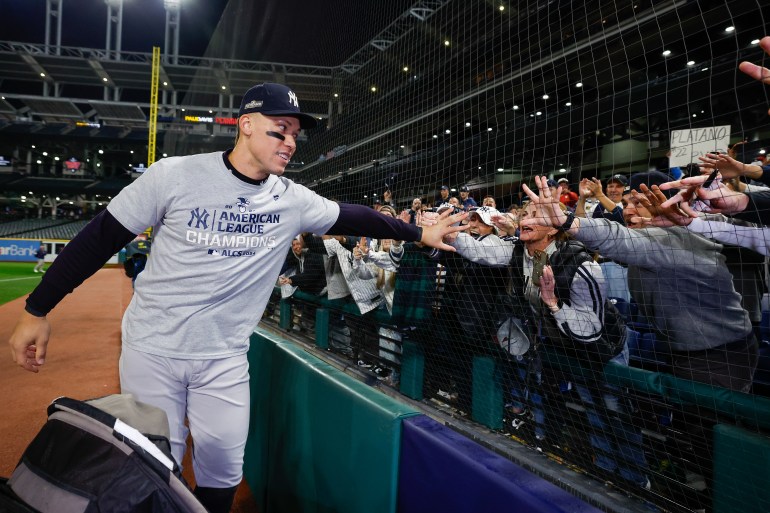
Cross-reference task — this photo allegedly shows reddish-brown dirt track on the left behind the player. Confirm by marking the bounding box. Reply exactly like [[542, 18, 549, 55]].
[[0, 268, 257, 513]]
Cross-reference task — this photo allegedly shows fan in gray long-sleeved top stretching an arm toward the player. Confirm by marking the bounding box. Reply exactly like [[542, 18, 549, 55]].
[[524, 173, 757, 392]]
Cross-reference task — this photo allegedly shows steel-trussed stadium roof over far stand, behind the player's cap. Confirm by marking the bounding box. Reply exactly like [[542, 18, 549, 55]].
[[0, 41, 335, 135]]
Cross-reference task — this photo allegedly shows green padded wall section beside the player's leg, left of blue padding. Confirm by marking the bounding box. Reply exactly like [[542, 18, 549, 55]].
[[244, 328, 419, 513]]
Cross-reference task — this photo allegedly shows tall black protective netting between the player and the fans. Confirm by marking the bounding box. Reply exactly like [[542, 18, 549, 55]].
[[256, 1, 770, 511]]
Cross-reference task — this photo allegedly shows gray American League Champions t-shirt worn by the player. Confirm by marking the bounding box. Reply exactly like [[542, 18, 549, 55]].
[[108, 152, 339, 359]]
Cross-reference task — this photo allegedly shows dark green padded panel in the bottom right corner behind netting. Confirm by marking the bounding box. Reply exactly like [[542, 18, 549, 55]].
[[714, 424, 770, 513]]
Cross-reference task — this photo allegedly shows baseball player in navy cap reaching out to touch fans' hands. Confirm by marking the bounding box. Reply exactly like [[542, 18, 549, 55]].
[[9, 83, 465, 513]]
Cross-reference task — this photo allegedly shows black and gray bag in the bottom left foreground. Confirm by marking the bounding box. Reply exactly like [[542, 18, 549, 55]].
[[9, 394, 206, 513]]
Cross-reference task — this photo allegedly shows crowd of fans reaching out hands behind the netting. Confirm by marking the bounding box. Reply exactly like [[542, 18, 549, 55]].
[[268, 142, 770, 489]]
